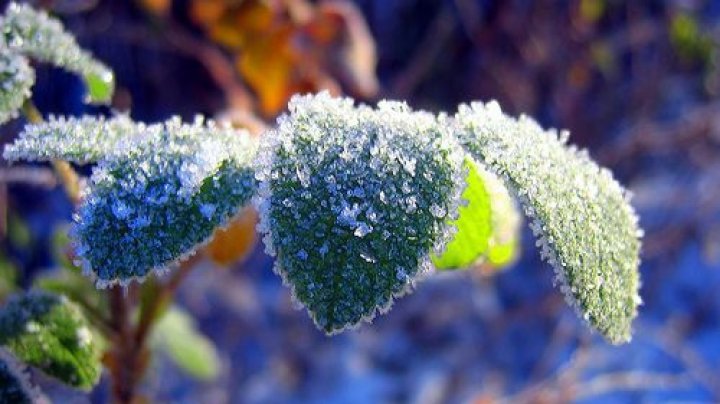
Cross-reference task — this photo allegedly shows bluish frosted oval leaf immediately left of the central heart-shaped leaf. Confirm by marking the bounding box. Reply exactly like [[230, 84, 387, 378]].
[[73, 119, 255, 287]]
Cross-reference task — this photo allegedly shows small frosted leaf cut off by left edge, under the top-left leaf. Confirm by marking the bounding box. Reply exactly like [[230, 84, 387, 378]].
[[0, 46, 35, 124]]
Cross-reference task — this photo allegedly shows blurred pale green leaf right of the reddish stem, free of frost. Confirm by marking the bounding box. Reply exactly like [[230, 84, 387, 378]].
[[151, 307, 220, 380]]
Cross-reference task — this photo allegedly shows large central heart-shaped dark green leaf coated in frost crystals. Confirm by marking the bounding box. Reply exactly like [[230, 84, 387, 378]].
[[257, 93, 463, 333]]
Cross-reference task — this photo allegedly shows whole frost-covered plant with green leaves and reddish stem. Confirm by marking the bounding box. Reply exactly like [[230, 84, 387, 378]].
[[0, 3, 641, 402]]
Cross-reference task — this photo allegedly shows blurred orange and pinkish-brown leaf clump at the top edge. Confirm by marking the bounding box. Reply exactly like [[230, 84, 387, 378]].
[[191, 0, 378, 116]]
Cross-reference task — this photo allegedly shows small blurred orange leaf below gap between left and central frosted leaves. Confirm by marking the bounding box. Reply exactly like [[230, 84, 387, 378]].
[[205, 206, 258, 267]]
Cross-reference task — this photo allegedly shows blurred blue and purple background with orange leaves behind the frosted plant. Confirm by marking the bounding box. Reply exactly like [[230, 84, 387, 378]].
[[0, 0, 720, 403]]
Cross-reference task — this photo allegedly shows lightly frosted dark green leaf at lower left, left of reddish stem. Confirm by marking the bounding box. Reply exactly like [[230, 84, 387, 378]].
[[0, 292, 102, 390]]
